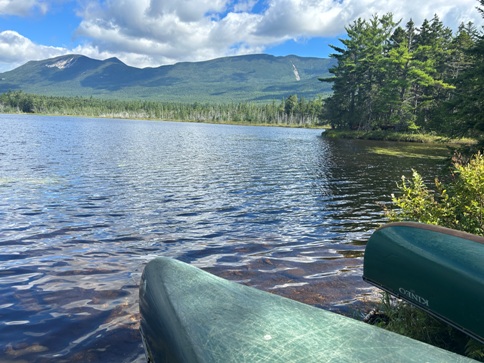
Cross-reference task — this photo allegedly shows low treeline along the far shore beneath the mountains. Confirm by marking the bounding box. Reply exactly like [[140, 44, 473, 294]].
[[0, 91, 324, 127]]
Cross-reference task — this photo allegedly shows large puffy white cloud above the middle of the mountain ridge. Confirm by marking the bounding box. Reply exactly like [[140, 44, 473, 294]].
[[74, 0, 263, 65]]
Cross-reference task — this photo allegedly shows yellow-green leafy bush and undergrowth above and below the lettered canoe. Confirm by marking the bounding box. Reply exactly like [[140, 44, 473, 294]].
[[379, 153, 484, 361]]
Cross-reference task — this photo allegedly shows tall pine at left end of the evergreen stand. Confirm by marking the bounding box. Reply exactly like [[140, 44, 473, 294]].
[[321, 14, 397, 130]]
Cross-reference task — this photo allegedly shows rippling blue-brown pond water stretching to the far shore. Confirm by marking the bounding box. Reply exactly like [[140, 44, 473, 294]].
[[0, 115, 446, 362]]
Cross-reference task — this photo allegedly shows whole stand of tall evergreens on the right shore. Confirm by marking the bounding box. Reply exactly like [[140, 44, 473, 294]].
[[321, 8, 484, 144]]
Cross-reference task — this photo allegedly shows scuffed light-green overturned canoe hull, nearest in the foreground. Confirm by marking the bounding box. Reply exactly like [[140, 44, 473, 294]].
[[140, 257, 472, 363]]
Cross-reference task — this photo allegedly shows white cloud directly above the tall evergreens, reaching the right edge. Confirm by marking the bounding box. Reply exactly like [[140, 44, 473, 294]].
[[257, 0, 481, 38]]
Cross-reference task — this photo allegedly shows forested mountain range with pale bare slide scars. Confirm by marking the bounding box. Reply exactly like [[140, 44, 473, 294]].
[[0, 54, 334, 102]]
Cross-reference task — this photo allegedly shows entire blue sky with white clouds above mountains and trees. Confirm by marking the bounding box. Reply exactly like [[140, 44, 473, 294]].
[[0, 0, 482, 72]]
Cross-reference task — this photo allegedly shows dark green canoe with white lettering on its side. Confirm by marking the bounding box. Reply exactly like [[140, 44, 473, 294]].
[[363, 222, 484, 343]]
